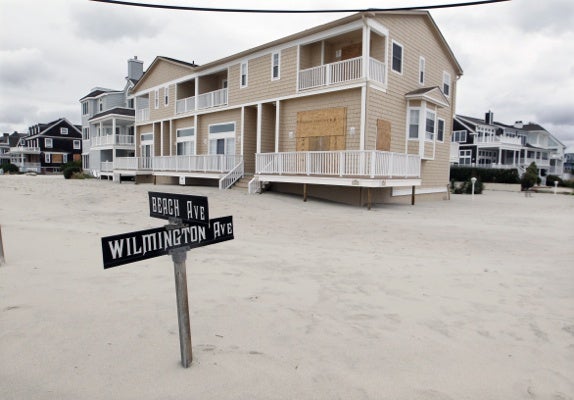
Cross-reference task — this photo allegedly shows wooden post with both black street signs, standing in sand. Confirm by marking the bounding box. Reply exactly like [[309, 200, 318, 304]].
[[102, 192, 234, 368]]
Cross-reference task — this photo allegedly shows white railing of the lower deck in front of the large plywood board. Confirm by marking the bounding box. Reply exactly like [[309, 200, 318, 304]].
[[255, 150, 421, 178]]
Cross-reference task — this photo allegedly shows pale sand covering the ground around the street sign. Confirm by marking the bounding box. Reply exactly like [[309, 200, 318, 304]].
[[0, 176, 574, 400]]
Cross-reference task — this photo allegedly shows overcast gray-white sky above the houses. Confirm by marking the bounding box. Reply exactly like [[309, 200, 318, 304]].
[[0, 0, 574, 151]]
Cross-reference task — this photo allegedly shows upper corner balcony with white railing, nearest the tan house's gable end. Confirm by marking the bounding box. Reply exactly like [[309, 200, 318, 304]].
[[297, 29, 387, 91]]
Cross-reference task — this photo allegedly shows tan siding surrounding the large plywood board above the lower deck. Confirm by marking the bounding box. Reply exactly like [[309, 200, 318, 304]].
[[279, 89, 361, 152]]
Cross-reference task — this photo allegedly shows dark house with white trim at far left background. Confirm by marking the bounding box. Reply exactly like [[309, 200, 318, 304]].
[[9, 118, 82, 173]]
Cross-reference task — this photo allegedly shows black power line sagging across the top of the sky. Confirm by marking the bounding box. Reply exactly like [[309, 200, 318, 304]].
[[90, 0, 511, 14]]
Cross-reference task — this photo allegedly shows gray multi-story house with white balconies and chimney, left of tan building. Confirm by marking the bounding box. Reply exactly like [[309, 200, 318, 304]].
[[80, 57, 143, 177]]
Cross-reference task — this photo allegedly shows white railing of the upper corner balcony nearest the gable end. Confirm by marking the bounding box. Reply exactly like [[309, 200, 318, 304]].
[[299, 57, 386, 90]]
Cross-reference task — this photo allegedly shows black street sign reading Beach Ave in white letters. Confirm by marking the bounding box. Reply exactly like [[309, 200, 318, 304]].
[[149, 192, 209, 225]]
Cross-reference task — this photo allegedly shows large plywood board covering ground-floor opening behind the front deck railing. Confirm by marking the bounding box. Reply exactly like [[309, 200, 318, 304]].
[[297, 107, 347, 151]]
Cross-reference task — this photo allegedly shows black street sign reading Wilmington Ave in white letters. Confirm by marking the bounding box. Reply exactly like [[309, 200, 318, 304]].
[[102, 216, 233, 269]]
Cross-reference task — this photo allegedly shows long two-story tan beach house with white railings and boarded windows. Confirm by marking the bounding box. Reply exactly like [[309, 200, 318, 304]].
[[113, 11, 462, 204]]
